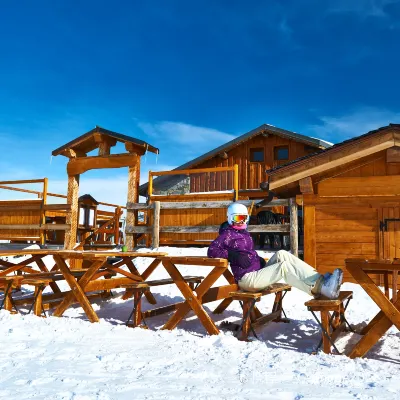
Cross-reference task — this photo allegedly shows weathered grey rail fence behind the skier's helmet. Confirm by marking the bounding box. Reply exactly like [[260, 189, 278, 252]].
[[125, 199, 298, 256]]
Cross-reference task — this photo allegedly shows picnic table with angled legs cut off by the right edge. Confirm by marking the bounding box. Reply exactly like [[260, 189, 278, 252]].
[[345, 259, 400, 358]]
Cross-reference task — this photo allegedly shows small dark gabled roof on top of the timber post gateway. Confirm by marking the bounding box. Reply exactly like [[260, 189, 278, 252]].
[[51, 125, 160, 156]]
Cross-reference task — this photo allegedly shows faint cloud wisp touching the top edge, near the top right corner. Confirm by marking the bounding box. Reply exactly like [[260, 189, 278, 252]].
[[329, 0, 399, 18]]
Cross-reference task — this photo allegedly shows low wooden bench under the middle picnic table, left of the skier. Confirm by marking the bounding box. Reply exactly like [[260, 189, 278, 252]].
[[121, 276, 204, 328]]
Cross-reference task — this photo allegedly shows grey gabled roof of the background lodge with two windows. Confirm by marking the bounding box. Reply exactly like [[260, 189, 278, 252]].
[[139, 124, 332, 196]]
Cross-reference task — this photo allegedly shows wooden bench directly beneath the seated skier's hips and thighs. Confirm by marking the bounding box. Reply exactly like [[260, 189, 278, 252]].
[[223, 283, 291, 340]]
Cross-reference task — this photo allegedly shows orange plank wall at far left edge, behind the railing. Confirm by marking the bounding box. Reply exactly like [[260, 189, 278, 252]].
[[0, 199, 43, 240]]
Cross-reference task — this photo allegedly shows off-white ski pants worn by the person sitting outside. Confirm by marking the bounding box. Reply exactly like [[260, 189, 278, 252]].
[[239, 250, 320, 295]]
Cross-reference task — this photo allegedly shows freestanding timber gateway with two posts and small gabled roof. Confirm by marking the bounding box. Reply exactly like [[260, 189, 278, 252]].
[[52, 126, 159, 250]]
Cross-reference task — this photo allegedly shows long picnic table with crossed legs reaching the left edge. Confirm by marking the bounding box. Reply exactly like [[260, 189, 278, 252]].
[[0, 249, 166, 322]]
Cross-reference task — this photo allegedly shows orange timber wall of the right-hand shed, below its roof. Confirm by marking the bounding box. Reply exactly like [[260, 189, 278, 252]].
[[302, 151, 400, 280]]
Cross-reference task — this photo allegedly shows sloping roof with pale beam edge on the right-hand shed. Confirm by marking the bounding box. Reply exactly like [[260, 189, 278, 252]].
[[266, 124, 400, 192]]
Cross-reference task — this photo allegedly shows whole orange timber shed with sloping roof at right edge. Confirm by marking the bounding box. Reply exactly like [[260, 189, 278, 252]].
[[268, 124, 400, 286]]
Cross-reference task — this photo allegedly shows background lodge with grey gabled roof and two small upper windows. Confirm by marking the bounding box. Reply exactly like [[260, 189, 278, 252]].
[[139, 124, 332, 198]]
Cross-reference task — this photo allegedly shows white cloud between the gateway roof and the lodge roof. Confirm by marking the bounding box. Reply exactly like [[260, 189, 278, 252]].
[[138, 121, 235, 147]]
